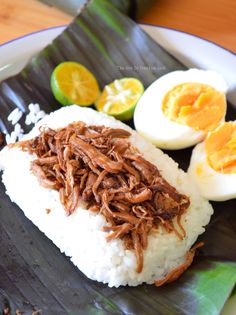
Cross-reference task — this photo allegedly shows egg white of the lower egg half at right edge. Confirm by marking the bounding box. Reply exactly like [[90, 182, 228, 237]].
[[188, 142, 236, 201]]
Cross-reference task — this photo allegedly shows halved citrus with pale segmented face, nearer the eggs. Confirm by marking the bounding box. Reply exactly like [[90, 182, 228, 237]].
[[95, 78, 144, 120]]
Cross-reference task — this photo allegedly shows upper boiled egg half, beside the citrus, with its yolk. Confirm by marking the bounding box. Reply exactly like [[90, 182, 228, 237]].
[[134, 69, 227, 150]]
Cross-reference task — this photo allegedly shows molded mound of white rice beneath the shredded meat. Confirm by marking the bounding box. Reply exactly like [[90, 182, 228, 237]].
[[0, 105, 213, 287]]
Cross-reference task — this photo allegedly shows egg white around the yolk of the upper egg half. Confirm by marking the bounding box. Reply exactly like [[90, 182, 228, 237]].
[[134, 69, 227, 150]]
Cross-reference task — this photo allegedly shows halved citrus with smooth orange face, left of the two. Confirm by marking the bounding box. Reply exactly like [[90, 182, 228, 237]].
[[51, 61, 100, 106]]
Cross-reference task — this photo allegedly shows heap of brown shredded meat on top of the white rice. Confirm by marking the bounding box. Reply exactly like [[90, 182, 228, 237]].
[[20, 122, 189, 272]]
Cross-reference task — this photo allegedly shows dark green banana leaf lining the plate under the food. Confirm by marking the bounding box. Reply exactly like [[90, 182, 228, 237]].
[[0, 0, 236, 315]]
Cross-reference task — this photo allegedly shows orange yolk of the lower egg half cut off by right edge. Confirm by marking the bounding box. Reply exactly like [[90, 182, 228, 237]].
[[205, 122, 236, 174]]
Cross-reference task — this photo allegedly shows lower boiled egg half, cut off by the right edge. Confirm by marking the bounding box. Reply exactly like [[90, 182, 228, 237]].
[[188, 121, 236, 201]]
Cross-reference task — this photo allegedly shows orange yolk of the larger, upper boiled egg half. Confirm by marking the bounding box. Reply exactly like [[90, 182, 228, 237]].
[[162, 82, 226, 131]]
